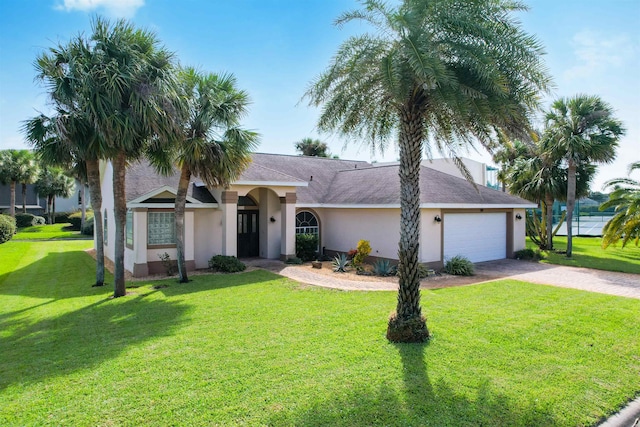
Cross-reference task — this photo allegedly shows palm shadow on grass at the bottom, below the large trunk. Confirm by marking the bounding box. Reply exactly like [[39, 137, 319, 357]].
[[269, 344, 557, 426]]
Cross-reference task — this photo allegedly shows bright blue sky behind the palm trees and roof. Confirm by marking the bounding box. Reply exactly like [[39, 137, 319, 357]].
[[0, 0, 640, 190]]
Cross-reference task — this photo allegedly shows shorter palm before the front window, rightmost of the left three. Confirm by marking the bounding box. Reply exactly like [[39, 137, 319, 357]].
[[164, 68, 258, 283]]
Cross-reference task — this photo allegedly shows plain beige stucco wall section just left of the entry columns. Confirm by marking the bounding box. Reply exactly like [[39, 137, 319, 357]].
[[194, 209, 222, 268]]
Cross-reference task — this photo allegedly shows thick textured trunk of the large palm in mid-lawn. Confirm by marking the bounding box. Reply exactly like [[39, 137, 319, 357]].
[[387, 107, 429, 342]]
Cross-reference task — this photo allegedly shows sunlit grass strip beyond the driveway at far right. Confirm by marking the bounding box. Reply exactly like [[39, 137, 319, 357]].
[[527, 236, 640, 274]]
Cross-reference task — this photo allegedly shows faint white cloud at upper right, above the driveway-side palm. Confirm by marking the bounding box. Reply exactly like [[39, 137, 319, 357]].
[[564, 31, 636, 80]]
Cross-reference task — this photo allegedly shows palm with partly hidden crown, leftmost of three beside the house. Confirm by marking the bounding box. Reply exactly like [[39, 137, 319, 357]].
[[22, 112, 106, 286]]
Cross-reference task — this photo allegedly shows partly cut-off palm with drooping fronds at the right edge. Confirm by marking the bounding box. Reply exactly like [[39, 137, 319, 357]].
[[600, 161, 640, 249]]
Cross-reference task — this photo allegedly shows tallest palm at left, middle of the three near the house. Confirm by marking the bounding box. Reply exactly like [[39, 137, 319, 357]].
[[38, 18, 180, 297]]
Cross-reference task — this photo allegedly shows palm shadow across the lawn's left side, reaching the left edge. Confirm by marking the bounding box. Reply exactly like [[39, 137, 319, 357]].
[[0, 291, 189, 390]]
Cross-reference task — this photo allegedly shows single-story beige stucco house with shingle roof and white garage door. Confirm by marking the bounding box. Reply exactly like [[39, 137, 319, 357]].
[[101, 153, 536, 276]]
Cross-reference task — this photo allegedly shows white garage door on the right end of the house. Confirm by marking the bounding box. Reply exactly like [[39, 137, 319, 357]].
[[443, 212, 507, 262]]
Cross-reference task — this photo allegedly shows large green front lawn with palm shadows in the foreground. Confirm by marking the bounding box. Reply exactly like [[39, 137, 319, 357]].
[[0, 241, 640, 426]]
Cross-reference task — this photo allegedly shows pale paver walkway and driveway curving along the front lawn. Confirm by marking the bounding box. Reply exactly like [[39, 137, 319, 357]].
[[250, 259, 640, 299]]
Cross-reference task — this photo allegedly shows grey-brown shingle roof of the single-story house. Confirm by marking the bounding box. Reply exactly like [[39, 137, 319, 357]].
[[126, 153, 531, 206]]
